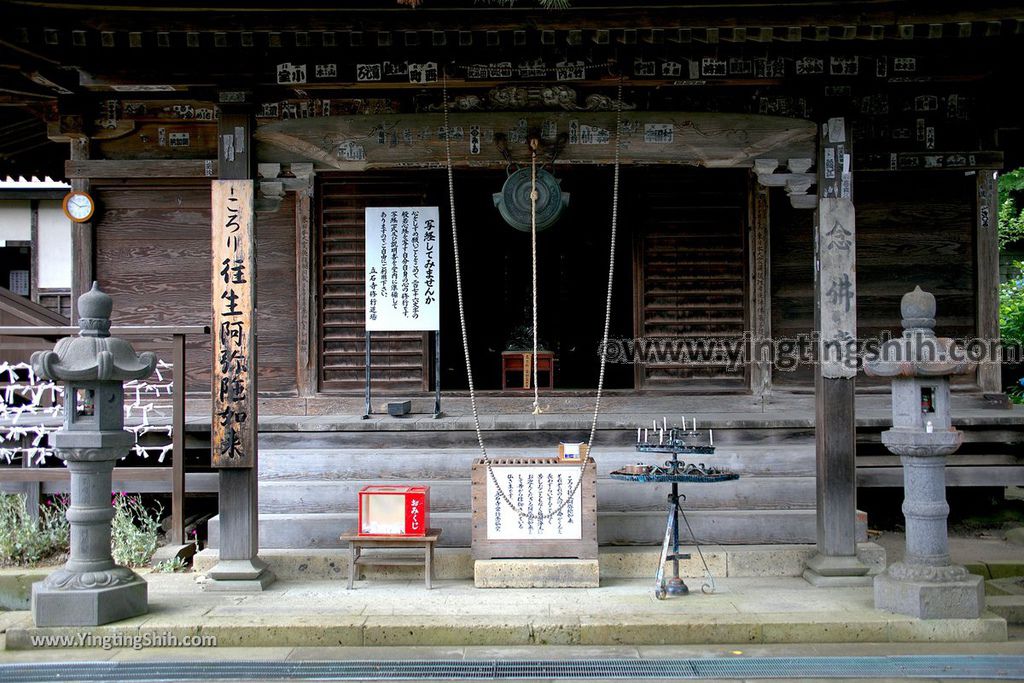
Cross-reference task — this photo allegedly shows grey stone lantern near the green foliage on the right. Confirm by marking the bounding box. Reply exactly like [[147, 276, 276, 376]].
[[864, 287, 985, 618]]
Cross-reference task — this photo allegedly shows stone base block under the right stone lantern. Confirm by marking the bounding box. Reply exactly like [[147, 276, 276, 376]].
[[874, 572, 985, 618]]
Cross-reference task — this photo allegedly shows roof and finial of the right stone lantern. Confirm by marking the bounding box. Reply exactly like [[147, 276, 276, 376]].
[[864, 287, 976, 377]]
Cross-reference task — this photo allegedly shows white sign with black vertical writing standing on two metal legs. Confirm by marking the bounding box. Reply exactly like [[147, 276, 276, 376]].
[[366, 207, 440, 331]]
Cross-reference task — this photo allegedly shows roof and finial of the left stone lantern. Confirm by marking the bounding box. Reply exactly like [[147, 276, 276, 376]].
[[32, 283, 157, 382]]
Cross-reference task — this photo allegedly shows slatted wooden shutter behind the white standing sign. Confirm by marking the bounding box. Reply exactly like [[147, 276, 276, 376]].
[[319, 173, 429, 397]]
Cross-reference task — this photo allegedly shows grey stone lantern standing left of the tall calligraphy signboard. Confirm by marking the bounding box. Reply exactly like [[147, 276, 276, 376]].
[[32, 283, 157, 626]]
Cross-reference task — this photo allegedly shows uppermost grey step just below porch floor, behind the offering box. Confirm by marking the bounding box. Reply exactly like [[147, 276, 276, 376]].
[[259, 444, 815, 483]]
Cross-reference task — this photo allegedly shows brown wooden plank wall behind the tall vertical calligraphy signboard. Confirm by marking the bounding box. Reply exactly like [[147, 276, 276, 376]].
[[93, 181, 296, 395]]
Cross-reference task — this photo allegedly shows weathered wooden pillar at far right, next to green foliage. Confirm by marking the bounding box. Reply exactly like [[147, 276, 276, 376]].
[[975, 169, 1002, 394]]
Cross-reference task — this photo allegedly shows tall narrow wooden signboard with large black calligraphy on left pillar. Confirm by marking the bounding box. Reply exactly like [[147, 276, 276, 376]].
[[212, 180, 256, 467]]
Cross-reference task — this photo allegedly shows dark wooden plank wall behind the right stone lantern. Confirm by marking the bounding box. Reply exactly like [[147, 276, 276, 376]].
[[771, 171, 976, 387]]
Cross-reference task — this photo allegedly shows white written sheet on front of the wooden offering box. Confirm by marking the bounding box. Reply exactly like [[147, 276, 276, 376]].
[[487, 465, 583, 541]]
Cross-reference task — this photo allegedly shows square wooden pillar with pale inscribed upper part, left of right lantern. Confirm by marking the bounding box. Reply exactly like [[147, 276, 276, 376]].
[[804, 119, 870, 586]]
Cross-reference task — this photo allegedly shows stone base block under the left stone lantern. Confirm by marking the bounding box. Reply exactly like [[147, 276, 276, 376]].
[[32, 577, 150, 626]]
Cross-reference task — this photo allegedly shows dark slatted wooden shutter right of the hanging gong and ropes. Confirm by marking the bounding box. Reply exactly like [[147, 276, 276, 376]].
[[635, 169, 746, 389]]
